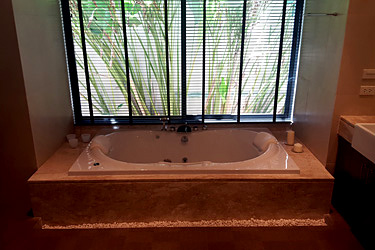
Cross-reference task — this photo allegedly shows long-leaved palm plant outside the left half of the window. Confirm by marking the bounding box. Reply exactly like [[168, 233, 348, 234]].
[[70, 0, 180, 115]]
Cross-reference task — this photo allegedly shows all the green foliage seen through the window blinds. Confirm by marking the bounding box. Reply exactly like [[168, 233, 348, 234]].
[[70, 0, 294, 116]]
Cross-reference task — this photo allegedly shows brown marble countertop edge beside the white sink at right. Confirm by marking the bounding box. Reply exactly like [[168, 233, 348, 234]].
[[337, 115, 375, 143]]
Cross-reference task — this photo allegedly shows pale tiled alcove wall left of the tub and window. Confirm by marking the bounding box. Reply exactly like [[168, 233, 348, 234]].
[[13, 0, 73, 166]]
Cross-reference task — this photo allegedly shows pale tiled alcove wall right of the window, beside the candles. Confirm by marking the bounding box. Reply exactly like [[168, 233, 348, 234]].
[[294, 0, 352, 168]]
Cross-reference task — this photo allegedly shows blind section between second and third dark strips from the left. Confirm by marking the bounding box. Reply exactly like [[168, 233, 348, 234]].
[[125, 1, 168, 116]]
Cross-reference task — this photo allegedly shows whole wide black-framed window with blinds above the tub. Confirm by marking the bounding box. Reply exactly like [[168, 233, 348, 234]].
[[61, 0, 303, 124]]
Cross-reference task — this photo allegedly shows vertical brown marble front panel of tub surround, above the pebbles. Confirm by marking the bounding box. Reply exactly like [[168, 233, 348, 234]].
[[30, 181, 332, 225]]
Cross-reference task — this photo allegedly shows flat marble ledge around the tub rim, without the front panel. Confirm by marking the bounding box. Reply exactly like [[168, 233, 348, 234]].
[[29, 129, 333, 183]]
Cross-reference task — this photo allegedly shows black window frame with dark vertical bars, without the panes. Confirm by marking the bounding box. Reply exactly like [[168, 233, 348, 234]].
[[60, 0, 304, 125]]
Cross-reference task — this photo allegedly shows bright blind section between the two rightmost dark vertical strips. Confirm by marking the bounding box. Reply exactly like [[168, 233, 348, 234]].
[[241, 0, 288, 115]]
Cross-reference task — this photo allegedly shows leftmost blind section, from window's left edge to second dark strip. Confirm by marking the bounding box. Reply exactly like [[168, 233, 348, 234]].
[[71, 0, 129, 116]]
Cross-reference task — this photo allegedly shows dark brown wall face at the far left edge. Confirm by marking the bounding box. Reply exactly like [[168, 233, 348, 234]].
[[0, 0, 37, 221]]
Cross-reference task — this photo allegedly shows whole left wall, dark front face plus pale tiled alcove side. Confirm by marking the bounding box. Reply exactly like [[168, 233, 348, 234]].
[[0, 0, 73, 222]]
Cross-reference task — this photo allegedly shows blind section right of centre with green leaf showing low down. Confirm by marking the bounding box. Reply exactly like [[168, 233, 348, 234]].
[[205, 0, 244, 115]]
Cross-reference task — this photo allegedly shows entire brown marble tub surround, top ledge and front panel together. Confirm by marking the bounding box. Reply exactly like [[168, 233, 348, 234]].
[[29, 127, 333, 225]]
